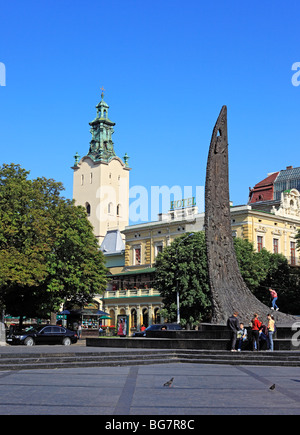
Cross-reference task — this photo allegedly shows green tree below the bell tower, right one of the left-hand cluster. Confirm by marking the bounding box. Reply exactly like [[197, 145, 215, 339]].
[[43, 201, 107, 316]]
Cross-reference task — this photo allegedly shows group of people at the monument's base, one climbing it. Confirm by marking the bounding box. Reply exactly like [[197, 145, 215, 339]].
[[227, 289, 279, 352]]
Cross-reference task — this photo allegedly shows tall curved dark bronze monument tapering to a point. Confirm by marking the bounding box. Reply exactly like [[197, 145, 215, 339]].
[[205, 106, 296, 325]]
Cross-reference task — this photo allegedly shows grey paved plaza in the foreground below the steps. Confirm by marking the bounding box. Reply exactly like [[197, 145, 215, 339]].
[[0, 346, 300, 418]]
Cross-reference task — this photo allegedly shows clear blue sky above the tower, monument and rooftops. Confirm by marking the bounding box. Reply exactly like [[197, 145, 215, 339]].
[[0, 0, 300, 223]]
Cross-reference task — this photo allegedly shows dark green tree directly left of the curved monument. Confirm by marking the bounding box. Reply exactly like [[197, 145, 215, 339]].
[[154, 232, 211, 326]]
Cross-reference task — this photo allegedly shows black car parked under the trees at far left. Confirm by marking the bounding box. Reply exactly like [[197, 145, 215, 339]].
[[6, 325, 78, 346]]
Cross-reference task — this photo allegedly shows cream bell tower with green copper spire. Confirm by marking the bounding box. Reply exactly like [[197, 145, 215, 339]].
[[72, 88, 130, 245]]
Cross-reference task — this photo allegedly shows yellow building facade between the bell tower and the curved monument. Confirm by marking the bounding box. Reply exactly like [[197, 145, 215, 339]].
[[103, 202, 204, 334]]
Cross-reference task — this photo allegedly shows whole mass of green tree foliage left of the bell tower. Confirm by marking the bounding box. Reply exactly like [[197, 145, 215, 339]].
[[0, 164, 106, 316]]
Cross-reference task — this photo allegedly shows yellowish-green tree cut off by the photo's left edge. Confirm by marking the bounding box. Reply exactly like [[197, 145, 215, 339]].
[[0, 164, 49, 288]]
